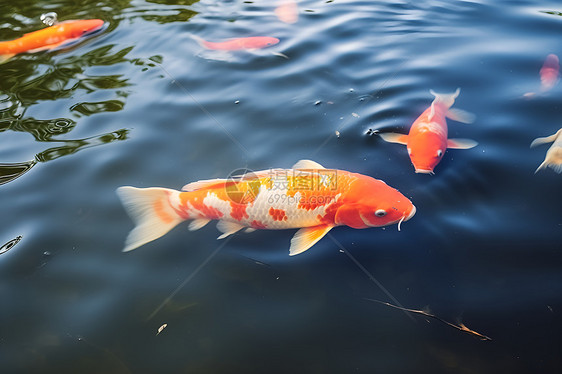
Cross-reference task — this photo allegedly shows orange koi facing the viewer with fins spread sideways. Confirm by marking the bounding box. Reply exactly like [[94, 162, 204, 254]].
[[380, 88, 478, 174]]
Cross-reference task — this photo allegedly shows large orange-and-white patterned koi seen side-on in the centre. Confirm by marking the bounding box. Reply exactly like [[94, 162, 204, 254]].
[[117, 160, 416, 256]]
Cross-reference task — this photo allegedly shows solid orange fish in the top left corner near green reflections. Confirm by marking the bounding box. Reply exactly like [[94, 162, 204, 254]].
[[0, 19, 104, 60]]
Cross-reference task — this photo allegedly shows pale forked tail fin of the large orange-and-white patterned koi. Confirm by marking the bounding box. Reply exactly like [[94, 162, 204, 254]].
[[117, 186, 183, 252]]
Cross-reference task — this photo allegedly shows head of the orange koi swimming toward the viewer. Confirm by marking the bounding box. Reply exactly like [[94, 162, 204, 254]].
[[406, 131, 447, 174]]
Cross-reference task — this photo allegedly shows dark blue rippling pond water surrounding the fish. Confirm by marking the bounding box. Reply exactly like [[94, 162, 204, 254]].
[[0, 0, 562, 373]]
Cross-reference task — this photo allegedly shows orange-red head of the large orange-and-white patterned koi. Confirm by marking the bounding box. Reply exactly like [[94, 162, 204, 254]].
[[334, 174, 416, 230]]
